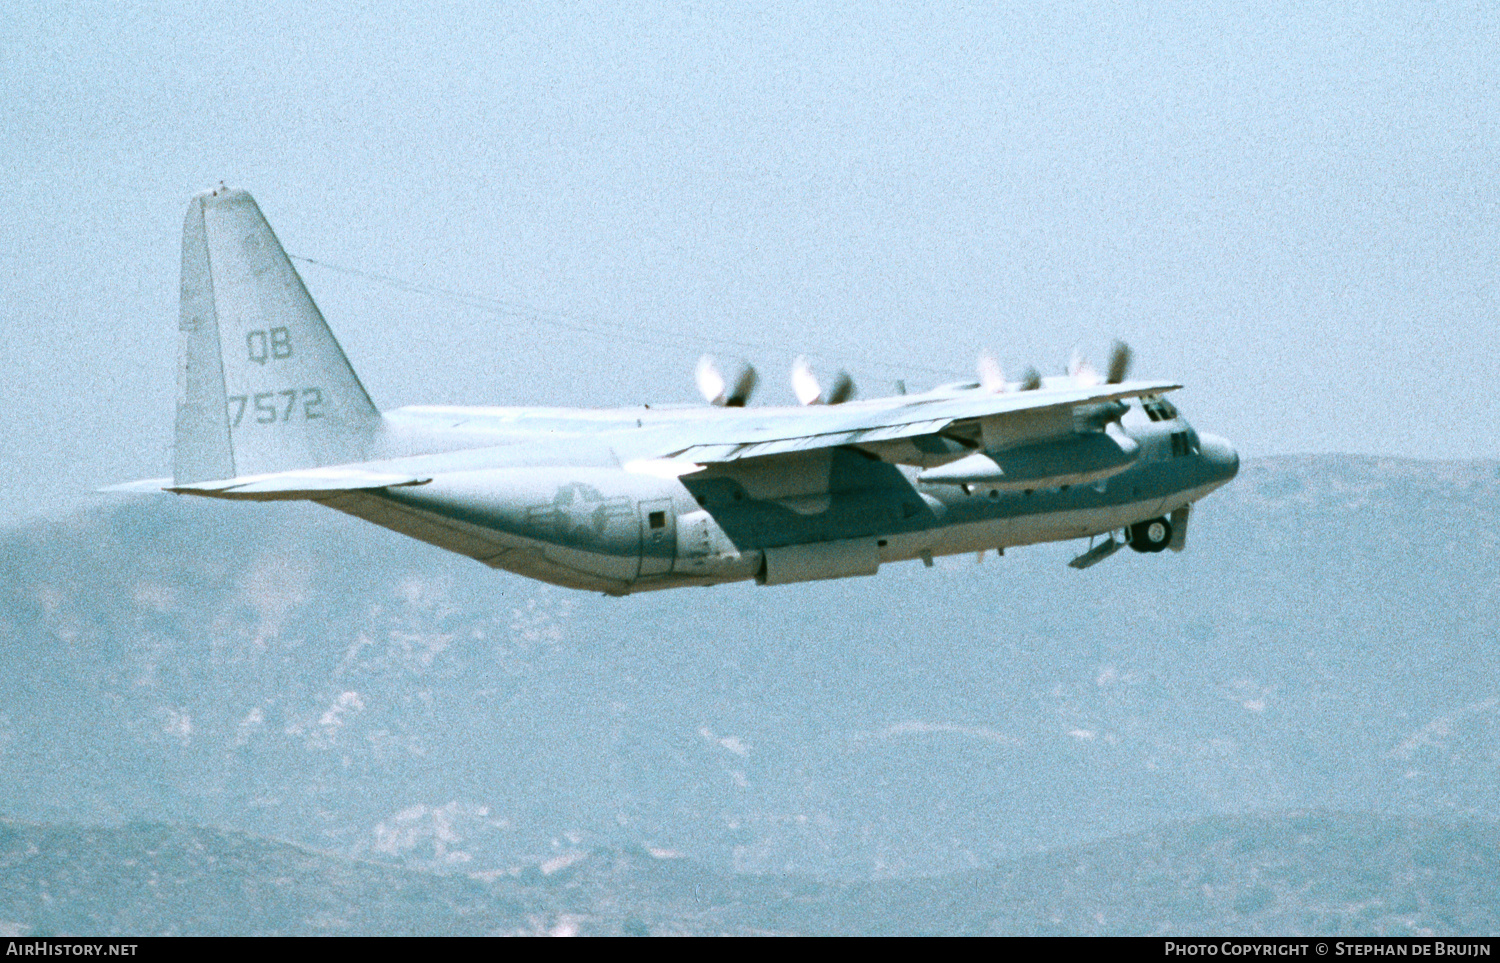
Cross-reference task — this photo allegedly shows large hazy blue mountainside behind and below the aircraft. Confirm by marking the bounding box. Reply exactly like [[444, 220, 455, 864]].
[[0, 456, 1500, 876]]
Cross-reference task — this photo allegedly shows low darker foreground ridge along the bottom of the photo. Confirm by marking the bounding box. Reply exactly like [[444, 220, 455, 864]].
[[0, 813, 1500, 936]]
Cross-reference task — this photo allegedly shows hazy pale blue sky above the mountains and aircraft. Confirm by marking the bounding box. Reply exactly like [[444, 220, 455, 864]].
[[0, 0, 1500, 521]]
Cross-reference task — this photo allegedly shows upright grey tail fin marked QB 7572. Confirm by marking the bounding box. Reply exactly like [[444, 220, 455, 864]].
[[173, 188, 380, 485]]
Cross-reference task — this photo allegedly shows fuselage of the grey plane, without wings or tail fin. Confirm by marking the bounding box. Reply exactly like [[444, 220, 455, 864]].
[[310, 396, 1239, 594]]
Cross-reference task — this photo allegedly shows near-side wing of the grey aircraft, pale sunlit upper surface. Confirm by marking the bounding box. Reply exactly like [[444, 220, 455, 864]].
[[668, 381, 1182, 465]]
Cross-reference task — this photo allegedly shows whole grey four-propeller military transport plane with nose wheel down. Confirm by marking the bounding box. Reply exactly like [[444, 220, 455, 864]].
[[113, 186, 1239, 596]]
